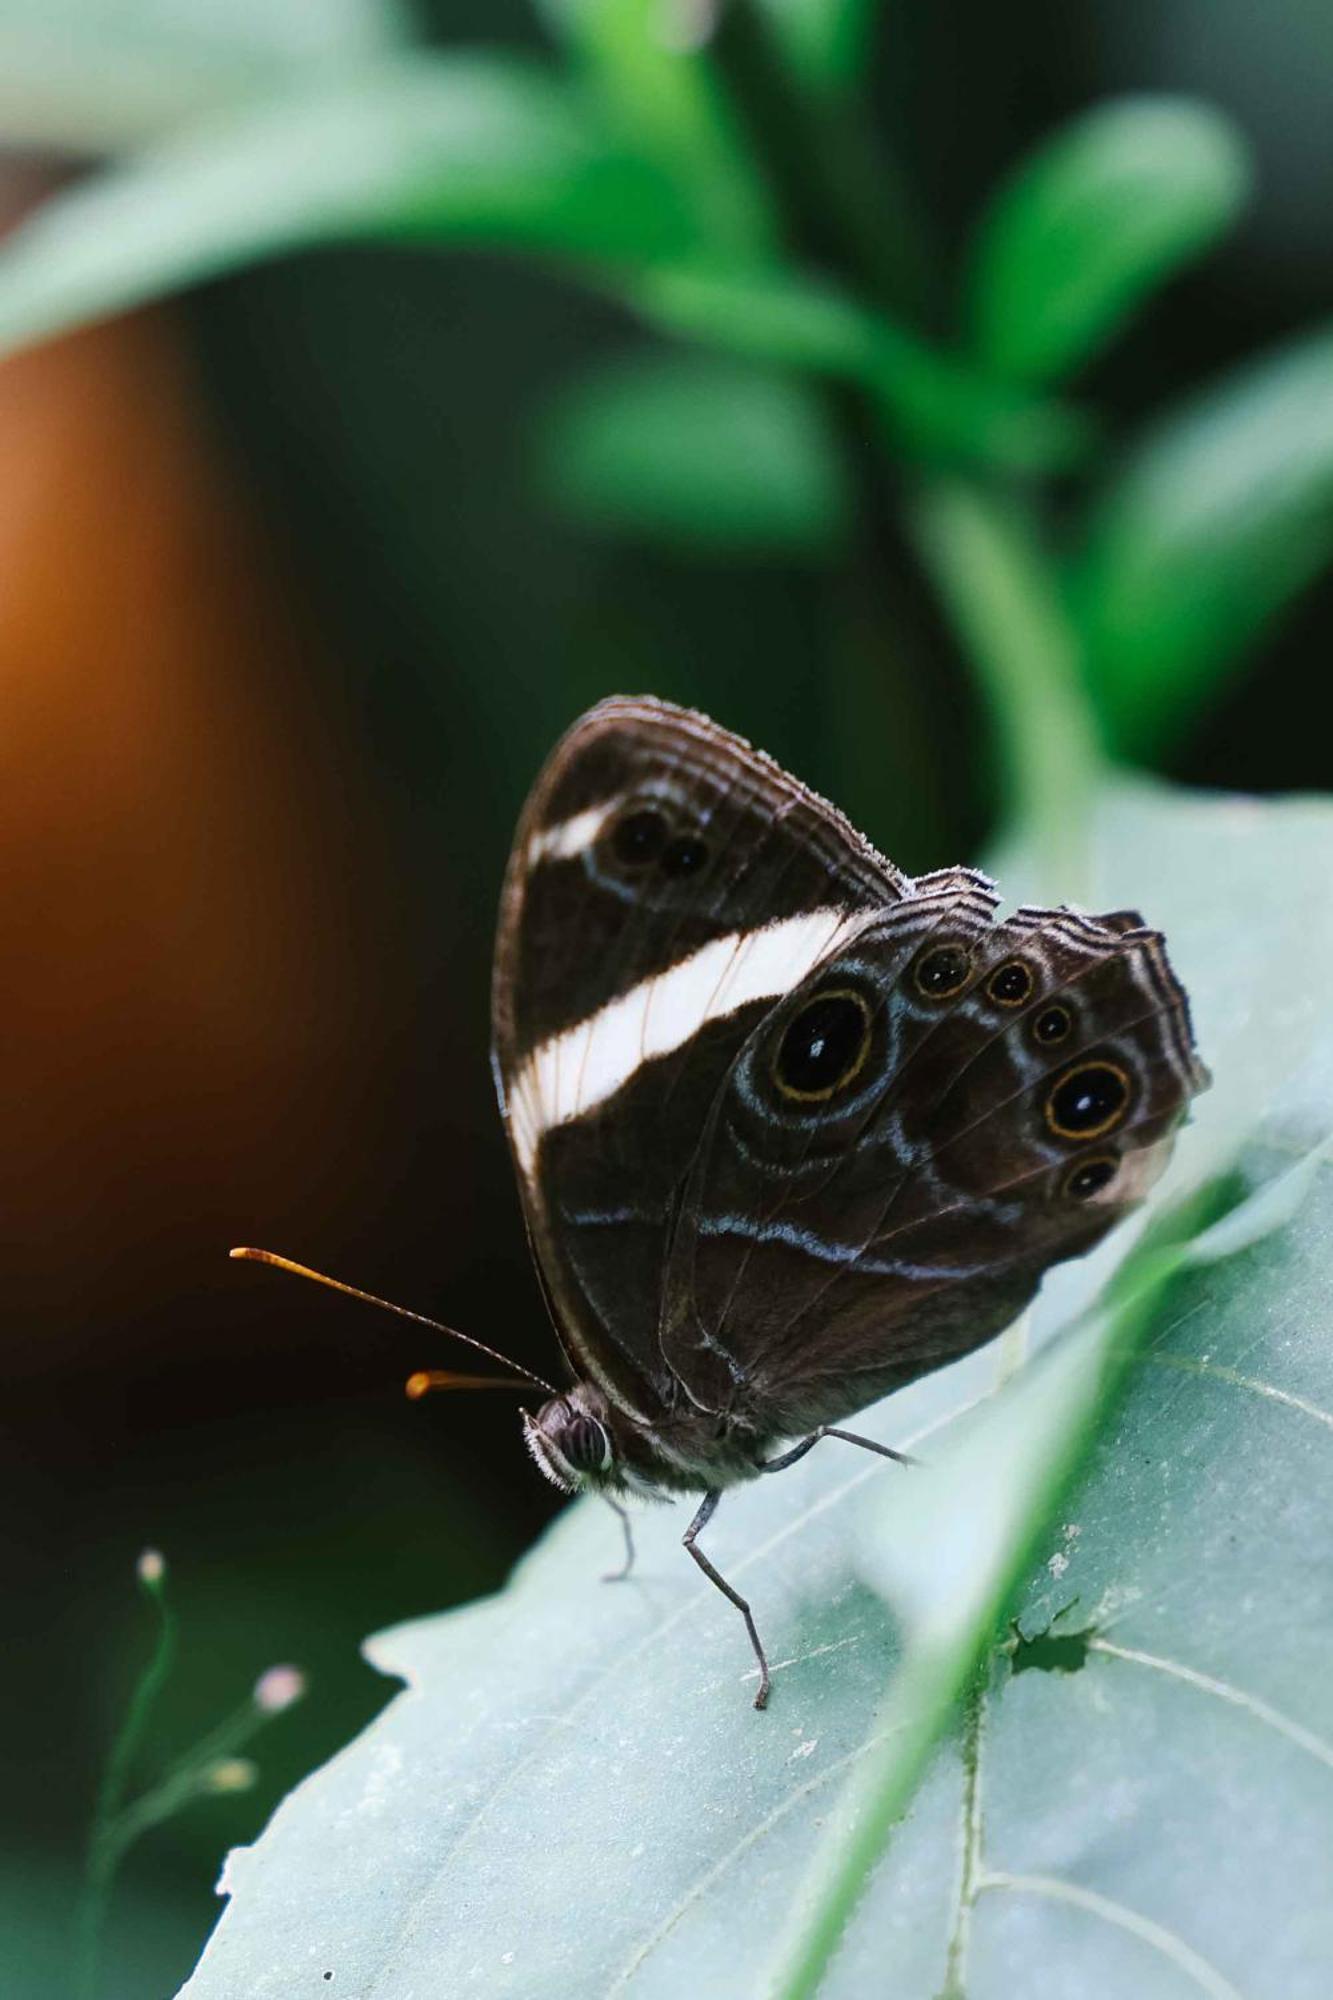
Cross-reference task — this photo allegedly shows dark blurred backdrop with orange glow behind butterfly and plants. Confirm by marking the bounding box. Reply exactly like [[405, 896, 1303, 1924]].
[[0, 0, 1333, 1994]]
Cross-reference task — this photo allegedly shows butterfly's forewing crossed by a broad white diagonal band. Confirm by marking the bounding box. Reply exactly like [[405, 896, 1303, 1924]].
[[492, 700, 907, 1414]]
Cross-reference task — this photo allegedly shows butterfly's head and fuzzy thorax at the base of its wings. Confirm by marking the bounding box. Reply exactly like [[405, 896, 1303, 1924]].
[[522, 1382, 765, 1498]]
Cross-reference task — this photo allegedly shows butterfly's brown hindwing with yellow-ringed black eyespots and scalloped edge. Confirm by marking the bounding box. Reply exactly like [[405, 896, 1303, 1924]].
[[662, 900, 1205, 1434]]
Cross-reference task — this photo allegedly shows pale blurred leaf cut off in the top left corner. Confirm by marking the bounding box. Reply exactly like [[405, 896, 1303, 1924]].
[[0, 0, 408, 154]]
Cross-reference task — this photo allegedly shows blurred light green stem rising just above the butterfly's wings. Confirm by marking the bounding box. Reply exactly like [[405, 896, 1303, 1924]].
[[909, 478, 1101, 896]]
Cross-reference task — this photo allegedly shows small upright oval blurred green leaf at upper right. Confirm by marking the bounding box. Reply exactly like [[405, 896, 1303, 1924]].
[[967, 98, 1251, 382]]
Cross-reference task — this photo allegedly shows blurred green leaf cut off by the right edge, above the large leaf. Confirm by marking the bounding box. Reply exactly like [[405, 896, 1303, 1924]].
[[1073, 328, 1333, 756]]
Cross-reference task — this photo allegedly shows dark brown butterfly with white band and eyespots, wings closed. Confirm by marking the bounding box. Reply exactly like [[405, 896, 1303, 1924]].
[[234, 696, 1209, 1708]]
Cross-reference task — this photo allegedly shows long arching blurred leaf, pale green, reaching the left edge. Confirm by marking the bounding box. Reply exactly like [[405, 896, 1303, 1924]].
[[0, 56, 695, 360]]
